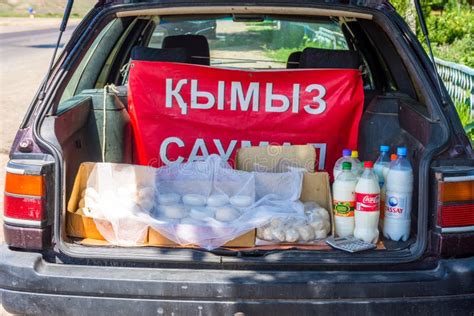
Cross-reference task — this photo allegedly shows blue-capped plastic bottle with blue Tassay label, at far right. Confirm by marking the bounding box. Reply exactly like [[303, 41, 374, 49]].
[[383, 147, 413, 241]]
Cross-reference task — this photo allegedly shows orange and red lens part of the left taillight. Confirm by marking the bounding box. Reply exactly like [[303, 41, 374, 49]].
[[4, 172, 45, 222]]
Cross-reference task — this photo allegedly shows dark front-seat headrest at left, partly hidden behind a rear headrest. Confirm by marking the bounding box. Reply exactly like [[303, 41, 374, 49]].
[[161, 34, 210, 66]]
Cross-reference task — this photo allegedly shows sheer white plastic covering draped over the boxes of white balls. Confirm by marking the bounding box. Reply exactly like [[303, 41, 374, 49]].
[[85, 155, 304, 249]]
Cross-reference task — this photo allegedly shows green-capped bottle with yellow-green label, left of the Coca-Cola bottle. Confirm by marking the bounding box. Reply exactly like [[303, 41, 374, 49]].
[[332, 161, 357, 237]]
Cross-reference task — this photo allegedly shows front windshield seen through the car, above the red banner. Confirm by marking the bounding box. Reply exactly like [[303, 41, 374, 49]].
[[149, 18, 348, 69]]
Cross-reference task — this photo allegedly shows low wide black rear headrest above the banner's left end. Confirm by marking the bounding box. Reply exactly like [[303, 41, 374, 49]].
[[131, 46, 188, 63]]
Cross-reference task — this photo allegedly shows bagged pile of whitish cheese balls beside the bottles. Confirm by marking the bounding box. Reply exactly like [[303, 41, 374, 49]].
[[257, 203, 331, 243]]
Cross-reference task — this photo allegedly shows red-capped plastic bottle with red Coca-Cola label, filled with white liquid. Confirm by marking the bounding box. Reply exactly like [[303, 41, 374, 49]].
[[354, 161, 380, 243]]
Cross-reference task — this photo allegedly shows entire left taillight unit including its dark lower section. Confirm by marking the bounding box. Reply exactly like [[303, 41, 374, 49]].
[[3, 159, 53, 250]]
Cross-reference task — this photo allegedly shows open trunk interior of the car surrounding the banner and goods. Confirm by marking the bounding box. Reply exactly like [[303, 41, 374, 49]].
[[41, 5, 448, 265]]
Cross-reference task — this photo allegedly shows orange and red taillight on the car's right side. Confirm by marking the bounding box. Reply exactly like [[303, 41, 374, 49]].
[[438, 176, 474, 232]]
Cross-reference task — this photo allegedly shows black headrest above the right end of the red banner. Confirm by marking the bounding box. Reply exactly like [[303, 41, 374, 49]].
[[300, 47, 361, 69]]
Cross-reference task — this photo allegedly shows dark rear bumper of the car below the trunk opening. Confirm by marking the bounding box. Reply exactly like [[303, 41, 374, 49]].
[[0, 246, 474, 315]]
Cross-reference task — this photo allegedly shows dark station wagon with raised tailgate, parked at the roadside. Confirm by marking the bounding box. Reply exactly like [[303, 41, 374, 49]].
[[0, 0, 474, 315]]
